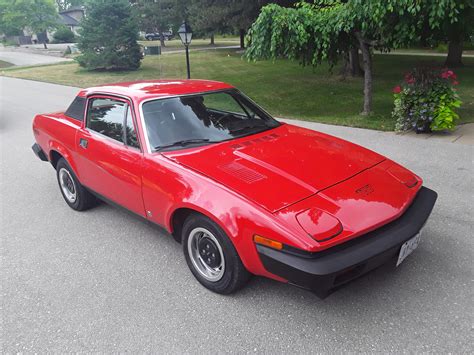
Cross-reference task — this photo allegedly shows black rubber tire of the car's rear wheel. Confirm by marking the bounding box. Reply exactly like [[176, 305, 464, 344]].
[[56, 158, 98, 211]]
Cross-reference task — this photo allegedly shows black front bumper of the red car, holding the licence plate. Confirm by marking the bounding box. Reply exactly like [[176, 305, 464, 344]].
[[257, 187, 438, 298]]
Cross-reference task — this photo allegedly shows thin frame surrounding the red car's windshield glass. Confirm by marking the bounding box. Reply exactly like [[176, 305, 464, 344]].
[[138, 88, 281, 154]]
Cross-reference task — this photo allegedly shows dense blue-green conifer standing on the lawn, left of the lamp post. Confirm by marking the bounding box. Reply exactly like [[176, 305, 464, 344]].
[[77, 0, 142, 70]]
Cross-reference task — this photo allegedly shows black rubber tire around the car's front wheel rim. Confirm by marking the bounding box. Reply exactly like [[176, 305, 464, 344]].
[[181, 214, 251, 294]]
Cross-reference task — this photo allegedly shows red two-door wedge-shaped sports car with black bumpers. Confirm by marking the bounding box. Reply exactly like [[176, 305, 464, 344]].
[[33, 80, 437, 297]]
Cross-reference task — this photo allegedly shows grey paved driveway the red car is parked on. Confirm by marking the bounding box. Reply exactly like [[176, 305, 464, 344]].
[[0, 77, 474, 354]]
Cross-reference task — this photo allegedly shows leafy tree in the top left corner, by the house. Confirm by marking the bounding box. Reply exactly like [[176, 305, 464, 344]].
[[0, 0, 58, 49]]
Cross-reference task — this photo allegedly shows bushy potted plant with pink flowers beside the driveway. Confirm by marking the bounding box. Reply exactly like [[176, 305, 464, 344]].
[[392, 68, 461, 133]]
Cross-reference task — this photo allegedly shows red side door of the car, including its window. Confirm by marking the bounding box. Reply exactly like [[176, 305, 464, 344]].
[[76, 95, 145, 216]]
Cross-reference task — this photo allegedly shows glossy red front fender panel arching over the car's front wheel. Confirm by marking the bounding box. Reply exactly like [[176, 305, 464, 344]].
[[142, 155, 315, 279]]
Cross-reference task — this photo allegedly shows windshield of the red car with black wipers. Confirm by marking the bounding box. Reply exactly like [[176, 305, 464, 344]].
[[143, 90, 279, 151]]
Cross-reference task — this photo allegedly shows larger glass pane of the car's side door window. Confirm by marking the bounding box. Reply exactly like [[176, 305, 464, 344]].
[[87, 98, 127, 142]]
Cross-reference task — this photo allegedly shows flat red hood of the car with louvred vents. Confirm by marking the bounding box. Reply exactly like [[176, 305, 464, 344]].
[[163, 124, 385, 212]]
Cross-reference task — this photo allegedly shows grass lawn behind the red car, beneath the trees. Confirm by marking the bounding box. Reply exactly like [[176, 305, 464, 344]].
[[2, 49, 474, 130]]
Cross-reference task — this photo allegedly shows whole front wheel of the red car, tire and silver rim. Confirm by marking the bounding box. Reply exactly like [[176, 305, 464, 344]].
[[182, 214, 250, 294]]
